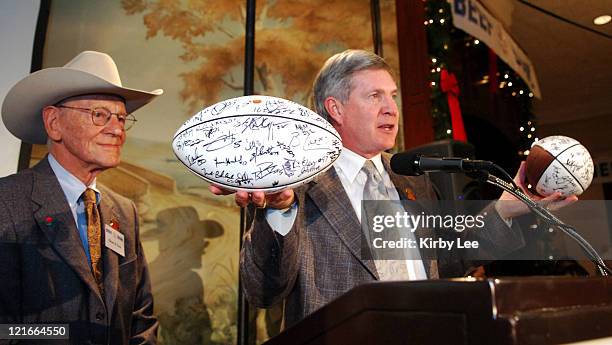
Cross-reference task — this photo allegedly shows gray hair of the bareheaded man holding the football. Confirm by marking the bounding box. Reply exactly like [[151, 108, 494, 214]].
[[313, 49, 393, 121]]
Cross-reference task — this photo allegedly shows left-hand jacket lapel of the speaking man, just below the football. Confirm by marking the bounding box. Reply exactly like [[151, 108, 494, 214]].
[[307, 167, 379, 279]]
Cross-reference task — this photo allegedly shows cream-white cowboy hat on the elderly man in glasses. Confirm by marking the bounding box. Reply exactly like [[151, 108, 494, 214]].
[[2, 51, 164, 144]]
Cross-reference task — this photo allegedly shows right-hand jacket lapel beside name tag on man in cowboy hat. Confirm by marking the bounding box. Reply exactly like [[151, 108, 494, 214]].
[[100, 192, 119, 315]]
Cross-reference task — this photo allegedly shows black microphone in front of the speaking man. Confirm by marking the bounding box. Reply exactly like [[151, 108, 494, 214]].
[[391, 152, 493, 176]]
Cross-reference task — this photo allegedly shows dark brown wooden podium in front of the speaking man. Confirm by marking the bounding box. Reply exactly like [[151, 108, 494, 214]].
[[265, 277, 612, 345]]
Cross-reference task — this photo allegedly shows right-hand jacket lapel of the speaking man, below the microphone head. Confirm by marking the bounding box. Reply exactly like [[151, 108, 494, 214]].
[[382, 153, 438, 279]]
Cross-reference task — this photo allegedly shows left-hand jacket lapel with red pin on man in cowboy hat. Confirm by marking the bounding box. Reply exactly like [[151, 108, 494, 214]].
[[32, 158, 102, 298]]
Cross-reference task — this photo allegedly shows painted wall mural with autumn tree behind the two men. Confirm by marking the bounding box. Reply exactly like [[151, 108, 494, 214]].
[[38, 0, 398, 345]]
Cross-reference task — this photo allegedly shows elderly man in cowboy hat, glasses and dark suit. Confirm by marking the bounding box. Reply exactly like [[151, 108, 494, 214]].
[[0, 51, 163, 345]]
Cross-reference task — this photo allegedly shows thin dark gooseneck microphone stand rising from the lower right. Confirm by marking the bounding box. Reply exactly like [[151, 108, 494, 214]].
[[467, 165, 612, 276]]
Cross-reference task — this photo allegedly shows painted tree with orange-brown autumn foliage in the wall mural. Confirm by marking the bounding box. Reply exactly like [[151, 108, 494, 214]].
[[122, 0, 397, 110]]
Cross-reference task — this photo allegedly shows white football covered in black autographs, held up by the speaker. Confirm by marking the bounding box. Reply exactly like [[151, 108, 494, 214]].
[[172, 96, 342, 192]]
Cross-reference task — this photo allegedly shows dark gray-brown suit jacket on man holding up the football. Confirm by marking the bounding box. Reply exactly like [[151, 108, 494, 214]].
[[240, 154, 523, 327]]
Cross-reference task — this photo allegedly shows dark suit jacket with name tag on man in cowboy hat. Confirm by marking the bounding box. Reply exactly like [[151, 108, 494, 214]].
[[0, 158, 158, 345]]
